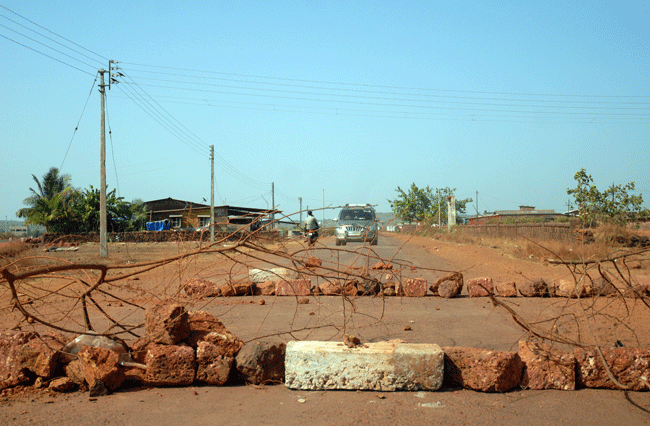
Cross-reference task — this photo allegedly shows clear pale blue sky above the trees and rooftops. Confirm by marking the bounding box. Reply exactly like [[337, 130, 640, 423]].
[[0, 0, 650, 220]]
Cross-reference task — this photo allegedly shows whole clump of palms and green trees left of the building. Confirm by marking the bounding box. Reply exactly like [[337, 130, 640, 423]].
[[17, 167, 146, 234]]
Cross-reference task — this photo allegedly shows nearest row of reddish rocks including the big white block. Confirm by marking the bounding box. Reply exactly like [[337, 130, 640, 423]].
[[0, 303, 650, 396]]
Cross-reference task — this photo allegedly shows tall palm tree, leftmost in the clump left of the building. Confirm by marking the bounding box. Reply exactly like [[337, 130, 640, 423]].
[[16, 167, 74, 231]]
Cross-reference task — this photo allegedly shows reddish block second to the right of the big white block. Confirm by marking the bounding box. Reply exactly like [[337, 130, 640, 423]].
[[519, 341, 576, 390]]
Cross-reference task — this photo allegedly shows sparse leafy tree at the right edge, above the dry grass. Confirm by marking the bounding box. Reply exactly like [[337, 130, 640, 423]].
[[567, 168, 648, 226]]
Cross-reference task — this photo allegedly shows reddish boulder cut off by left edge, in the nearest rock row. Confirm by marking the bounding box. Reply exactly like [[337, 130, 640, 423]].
[[0, 330, 37, 390]]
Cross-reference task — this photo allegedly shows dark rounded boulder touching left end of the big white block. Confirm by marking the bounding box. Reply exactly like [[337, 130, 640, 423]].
[[236, 341, 286, 385]]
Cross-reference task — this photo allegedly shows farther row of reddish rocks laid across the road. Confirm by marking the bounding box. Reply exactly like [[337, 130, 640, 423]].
[[183, 258, 650, 299]]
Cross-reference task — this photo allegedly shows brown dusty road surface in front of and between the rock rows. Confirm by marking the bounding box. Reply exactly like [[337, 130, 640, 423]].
[[0, 235, 650, 425]]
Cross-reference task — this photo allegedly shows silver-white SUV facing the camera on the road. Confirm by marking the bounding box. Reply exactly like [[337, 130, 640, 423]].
[[334, 204, 379, 246]]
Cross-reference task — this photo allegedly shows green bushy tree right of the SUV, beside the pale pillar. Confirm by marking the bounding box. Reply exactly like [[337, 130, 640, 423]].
[[388, 183, 472, 223]]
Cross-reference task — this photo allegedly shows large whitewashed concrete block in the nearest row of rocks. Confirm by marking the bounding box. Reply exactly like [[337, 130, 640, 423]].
[[284, 341, 444, 391]]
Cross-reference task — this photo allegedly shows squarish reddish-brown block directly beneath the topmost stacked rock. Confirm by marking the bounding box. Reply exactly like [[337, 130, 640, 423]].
[[144, 345, 196, 386]]
